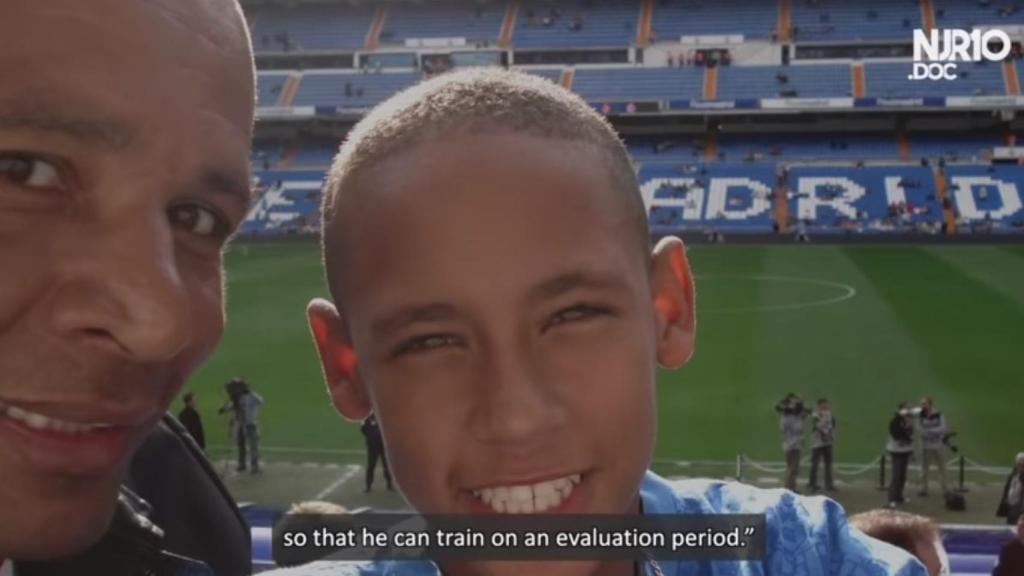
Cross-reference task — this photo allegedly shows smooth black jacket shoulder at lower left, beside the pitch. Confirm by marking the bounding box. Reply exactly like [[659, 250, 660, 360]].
[[125, 415, 252, 576]]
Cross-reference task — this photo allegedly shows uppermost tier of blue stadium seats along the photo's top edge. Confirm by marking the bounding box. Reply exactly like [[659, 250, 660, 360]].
[[247, 0, 1024, 52]]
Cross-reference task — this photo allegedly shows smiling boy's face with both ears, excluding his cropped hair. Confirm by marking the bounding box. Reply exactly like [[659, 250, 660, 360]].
[[310, 132, 693, 573]]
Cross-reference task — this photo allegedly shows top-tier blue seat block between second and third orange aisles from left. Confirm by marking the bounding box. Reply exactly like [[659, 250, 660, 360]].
[[512, 0, 640, 48]]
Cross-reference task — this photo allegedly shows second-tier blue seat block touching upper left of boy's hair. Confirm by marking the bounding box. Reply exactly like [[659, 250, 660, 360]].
[[293, 72, 420, 109]]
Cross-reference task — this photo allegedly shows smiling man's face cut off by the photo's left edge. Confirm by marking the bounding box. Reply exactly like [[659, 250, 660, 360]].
[[0, 0, 253, 560]]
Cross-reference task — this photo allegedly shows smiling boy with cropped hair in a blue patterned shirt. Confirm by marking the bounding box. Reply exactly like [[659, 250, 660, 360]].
[[268, 70, 924, 576]]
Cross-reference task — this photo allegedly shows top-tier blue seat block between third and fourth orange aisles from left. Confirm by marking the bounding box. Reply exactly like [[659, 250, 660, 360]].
[[652, 0, 778, 41]]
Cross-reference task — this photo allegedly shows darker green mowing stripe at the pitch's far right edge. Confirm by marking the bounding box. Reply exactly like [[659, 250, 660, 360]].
[[847, 242, 1024, 462]]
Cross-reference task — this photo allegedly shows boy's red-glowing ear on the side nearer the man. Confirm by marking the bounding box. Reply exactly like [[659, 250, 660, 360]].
[[306, 298, 372, 420]]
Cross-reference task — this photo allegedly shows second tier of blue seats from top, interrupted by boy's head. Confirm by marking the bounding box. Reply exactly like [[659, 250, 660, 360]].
[[258, 58, 1024, 110]]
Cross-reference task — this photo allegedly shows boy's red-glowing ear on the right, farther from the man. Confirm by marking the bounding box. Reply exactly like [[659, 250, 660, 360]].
[[650, 237, 696, 368]]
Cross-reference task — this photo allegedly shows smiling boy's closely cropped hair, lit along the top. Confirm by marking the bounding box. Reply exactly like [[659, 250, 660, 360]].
[[323, 69, 650, 301]]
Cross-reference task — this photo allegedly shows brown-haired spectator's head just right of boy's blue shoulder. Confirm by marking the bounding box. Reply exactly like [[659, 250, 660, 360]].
[[850, 509, 949, 576]]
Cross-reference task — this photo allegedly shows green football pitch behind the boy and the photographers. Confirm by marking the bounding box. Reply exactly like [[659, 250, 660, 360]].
[[186, 243, 1024, 467]]
